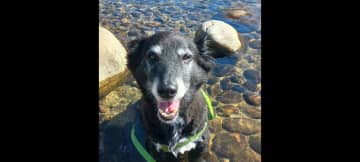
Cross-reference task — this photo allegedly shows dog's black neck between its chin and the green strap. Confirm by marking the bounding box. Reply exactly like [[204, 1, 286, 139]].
[[140, 91, 207, 146]]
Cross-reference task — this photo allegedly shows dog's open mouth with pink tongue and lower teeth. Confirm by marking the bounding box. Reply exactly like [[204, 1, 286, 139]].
[[158, 100, 180, 121]]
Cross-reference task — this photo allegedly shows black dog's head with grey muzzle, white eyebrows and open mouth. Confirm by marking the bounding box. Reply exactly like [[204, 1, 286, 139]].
[[128, 32, 215, 123]]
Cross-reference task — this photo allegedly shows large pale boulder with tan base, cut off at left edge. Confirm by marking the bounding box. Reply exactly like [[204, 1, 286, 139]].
[[99, 26, 128, 97]]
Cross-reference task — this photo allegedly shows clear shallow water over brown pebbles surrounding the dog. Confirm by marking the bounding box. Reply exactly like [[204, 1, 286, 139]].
[[99, 0, 261, 162]]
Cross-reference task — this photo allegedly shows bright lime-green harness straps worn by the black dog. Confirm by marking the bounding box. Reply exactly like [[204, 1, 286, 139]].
[[131, 89, 216, 162]]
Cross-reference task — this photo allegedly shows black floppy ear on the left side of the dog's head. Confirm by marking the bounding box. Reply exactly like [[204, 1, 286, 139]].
[[127, 38, 145, 72]]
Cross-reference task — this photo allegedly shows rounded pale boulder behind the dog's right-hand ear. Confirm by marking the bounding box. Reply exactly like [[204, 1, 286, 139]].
[[195, 20, 242, 55]]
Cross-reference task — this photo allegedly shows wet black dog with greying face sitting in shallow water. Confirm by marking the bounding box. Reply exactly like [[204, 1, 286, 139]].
[[103, 32, 228, 162]]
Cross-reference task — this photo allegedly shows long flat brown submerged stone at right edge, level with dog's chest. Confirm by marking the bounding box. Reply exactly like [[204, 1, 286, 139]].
[[222, 118, 261, 135]]
